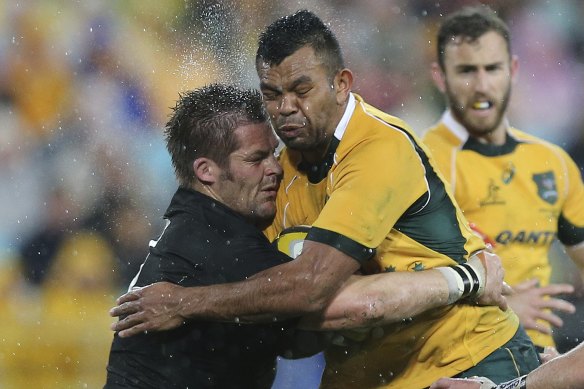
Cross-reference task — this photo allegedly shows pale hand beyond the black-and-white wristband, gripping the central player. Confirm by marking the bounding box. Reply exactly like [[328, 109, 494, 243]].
[[471, 251, 513, 311]]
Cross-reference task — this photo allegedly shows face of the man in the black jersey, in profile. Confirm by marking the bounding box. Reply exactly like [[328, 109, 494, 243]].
[[216, 123, 282, 229]]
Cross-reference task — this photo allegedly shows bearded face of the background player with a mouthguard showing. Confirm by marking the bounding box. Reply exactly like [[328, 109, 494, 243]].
[[443, 31, 517, 137]]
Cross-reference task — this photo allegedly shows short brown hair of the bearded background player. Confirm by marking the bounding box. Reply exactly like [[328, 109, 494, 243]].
[[437, 5, 511, 70]]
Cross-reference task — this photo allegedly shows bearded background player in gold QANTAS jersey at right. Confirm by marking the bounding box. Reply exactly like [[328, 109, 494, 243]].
[[424, 6, 584, 347]]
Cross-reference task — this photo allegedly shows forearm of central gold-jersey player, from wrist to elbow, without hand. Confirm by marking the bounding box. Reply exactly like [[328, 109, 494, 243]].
[[180, 245, 358, 322]]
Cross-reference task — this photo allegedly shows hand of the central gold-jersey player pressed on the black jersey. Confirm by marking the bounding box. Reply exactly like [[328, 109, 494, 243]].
[[109, 282, 185, 338]]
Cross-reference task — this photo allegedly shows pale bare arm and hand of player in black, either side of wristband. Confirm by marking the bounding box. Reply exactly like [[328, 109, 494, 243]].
[[299, 250, 511, 330]]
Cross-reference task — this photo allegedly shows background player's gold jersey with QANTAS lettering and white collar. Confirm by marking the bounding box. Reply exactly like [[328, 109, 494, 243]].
[[424, 112, 584, 346]]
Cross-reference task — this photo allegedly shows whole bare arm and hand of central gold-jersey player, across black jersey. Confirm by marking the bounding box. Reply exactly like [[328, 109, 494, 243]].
[[110, 241, 359, 337]]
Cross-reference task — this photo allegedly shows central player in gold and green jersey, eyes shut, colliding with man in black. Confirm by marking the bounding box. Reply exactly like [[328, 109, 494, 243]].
[[112, 11, 539, 389]]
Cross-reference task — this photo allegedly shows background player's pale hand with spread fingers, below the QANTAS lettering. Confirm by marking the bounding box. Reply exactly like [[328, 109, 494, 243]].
[[507, 279, 576, 334]]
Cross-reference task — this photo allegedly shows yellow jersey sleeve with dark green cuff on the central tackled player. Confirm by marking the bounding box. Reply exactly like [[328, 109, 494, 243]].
[[307, 130, 427, 260]]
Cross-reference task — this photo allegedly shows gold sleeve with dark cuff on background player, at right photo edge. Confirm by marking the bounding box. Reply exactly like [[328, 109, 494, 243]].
[[558, 150, 584, 246]]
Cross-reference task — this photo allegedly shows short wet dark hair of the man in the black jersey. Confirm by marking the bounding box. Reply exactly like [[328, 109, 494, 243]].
[[164, 84, 268, 187]]
